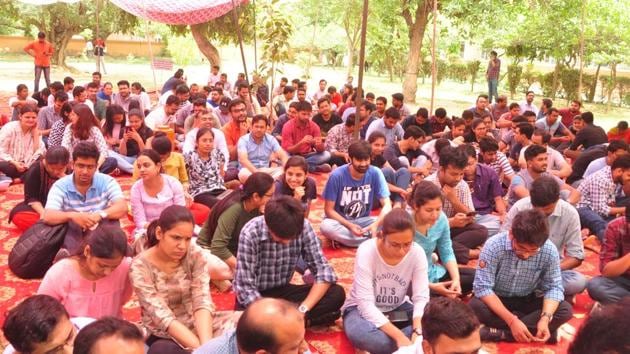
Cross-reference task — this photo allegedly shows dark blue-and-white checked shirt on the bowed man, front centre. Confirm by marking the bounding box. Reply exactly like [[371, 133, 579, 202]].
[[234, 216, 337, 306]]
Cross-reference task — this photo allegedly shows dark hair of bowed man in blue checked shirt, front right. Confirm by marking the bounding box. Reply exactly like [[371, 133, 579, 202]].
[[512, 209, 549, 247]]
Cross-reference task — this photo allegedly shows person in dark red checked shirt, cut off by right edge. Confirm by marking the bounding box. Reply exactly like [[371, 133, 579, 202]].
[[587, 202, 630, 304]]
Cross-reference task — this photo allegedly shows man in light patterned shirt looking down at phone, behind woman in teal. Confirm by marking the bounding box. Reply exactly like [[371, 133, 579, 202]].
[[425, 146, 488, 264]]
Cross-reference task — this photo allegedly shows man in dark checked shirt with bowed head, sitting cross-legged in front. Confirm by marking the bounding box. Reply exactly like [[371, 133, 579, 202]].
[[234, 196, 346, 327]]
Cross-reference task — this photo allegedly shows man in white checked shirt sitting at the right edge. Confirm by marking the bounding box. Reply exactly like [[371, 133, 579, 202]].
[[577, 154, 630, 242]]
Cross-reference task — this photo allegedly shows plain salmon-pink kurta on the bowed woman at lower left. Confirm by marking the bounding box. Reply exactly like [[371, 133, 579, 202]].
[[37, 257, 132, 319]]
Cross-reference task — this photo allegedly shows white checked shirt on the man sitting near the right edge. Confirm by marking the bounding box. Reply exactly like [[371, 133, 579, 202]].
[[576, 166, 615, 217]]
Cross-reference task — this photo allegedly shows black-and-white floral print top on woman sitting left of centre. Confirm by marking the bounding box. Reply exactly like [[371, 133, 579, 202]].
[[184, 149, 225, 197]]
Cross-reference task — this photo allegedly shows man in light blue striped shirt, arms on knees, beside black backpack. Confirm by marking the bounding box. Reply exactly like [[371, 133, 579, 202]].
[[42, 141, 127, 256]]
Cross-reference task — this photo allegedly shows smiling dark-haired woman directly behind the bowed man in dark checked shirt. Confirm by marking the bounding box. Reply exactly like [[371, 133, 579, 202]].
[[273, 156, 317, 218]]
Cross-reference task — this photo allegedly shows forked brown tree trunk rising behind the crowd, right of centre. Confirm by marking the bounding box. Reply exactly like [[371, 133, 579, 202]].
[[402, 0, 431, 103]]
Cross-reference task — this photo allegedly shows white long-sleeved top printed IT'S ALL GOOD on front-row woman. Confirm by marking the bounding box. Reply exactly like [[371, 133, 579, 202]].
[[342, 238, 429, 327]]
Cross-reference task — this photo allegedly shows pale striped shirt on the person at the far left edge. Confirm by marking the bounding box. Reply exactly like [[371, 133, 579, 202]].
[[0, 121, 46, 168]]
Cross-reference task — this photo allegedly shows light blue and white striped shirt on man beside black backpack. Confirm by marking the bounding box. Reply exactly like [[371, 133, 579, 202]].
[[46, 172, 124, 213]]
